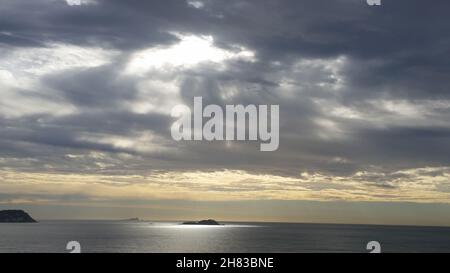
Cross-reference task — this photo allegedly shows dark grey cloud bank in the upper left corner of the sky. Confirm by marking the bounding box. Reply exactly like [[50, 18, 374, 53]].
[[0, 0, 176, 50]]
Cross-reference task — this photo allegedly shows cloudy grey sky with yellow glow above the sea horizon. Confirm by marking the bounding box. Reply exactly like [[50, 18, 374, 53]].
[[0, 0, 450, 225]]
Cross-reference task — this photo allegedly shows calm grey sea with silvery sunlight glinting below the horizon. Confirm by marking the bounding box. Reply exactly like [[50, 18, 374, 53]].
[[0, 221, 450, 253]]
